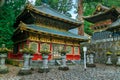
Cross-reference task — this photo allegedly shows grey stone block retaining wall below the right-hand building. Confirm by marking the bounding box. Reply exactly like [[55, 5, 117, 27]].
[[86, 40, 120, 64]]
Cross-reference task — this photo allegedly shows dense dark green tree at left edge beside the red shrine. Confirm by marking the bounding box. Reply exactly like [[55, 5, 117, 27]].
[[0, 0, 26, 48]]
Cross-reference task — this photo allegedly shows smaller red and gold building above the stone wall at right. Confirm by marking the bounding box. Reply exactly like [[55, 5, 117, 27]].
[[84, 4, 120, 43]]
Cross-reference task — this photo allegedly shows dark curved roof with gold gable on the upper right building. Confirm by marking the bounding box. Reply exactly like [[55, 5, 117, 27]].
[[83, 4, 120, 23]]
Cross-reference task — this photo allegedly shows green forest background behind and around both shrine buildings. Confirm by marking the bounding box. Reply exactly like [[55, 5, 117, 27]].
[[0, 0, 120, 48]]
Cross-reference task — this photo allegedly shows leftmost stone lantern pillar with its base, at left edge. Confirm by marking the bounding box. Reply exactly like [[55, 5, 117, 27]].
[[0, 54, 8, 73]]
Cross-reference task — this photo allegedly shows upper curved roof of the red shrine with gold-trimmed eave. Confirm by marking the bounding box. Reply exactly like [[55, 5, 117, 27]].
[[17, 3, 82, 26]]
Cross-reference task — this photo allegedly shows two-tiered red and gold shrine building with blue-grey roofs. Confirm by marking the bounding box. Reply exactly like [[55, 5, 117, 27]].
[[9, 4, 88, 60]]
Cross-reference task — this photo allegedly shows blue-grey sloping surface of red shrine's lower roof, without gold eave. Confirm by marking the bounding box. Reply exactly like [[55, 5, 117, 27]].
[[26, 24, 88, 40]]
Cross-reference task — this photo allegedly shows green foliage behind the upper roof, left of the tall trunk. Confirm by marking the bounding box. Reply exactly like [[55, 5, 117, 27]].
[[35, 0, 73, 17]]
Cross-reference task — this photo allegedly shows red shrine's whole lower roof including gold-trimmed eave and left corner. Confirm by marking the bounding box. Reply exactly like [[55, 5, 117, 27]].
[[14, 24, 88, 42]]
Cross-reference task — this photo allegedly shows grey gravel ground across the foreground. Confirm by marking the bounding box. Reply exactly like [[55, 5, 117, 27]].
[[0, 64, 120, 80]]
